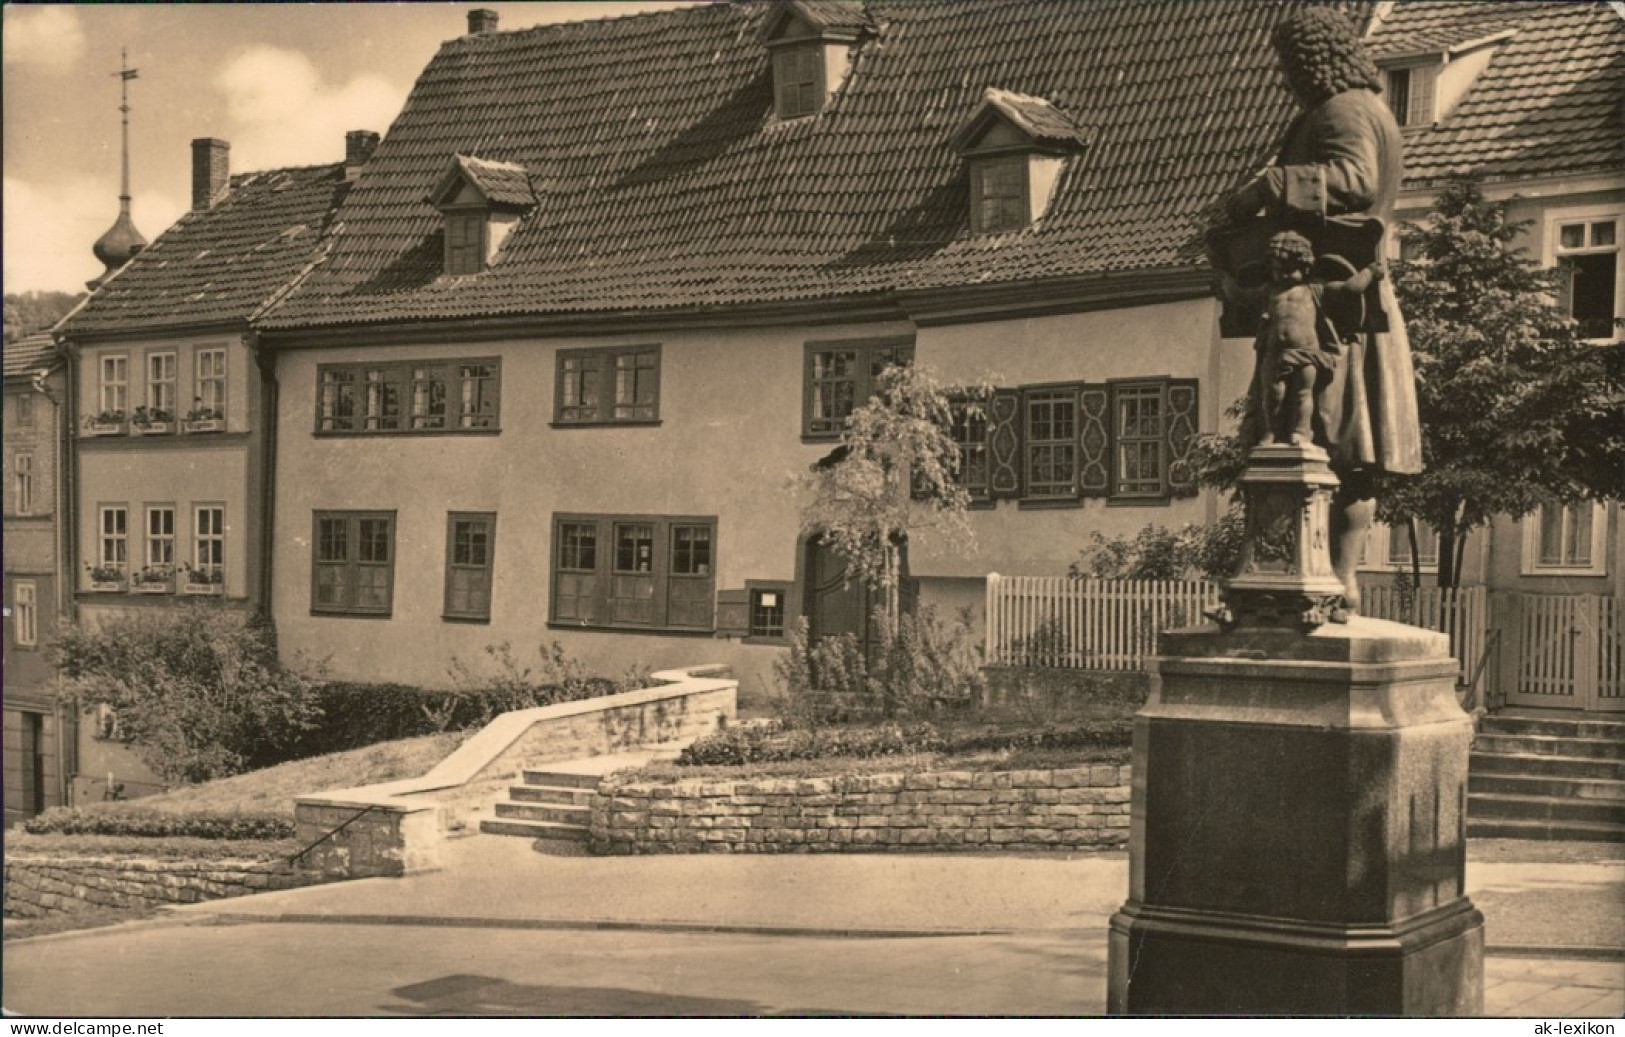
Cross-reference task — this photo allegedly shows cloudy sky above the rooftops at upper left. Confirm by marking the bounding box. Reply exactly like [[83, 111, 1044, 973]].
[[3, 0, 705, 293]]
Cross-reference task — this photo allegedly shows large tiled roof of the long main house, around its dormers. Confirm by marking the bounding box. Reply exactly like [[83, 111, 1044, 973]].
[[267, 0, 1363, 328]]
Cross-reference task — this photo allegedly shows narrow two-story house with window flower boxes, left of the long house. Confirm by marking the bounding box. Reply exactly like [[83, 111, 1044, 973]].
[[57, 132, 377, 798]]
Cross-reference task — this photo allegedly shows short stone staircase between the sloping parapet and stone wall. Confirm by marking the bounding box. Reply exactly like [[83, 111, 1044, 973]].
[[479, 753, 670, 857]]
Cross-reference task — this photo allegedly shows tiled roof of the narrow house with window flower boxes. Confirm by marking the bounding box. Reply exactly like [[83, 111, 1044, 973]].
[[60, 164, 348, 335]]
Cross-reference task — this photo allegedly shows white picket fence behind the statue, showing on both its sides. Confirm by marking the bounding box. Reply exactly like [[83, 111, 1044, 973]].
[[986, 572, 1489, 683]]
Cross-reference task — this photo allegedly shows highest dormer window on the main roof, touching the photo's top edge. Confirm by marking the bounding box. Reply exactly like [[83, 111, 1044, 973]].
[[761, 0, 874, 120]]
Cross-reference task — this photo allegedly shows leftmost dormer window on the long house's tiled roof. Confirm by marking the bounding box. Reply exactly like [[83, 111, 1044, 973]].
[[427, 154, 536, 276]]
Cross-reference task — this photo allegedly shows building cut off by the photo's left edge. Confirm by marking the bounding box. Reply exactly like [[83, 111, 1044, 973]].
[[3, 332, 75, 827]]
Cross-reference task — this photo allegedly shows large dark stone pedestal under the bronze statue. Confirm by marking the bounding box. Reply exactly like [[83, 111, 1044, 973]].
[[1108, 618, 1484, 1016]]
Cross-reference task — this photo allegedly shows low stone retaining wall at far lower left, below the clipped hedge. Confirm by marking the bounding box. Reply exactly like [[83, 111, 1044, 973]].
[[5, 853, 322, 918]]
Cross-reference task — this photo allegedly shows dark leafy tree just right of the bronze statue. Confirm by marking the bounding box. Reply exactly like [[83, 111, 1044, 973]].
[[1380, 179, 1625, 587]]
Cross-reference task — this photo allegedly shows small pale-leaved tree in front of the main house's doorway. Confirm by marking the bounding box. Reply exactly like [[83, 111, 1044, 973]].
[[800, 366, 991, 627]]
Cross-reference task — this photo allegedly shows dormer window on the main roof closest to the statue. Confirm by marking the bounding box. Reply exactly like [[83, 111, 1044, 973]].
[[951, 89, 1087, 234]]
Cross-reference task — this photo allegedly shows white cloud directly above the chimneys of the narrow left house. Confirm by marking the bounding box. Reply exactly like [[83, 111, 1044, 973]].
[[215, 47, 406, 171]]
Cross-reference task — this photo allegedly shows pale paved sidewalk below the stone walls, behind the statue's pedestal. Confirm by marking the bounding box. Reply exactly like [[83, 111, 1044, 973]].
[[168, 835, 1625, 1017]]
